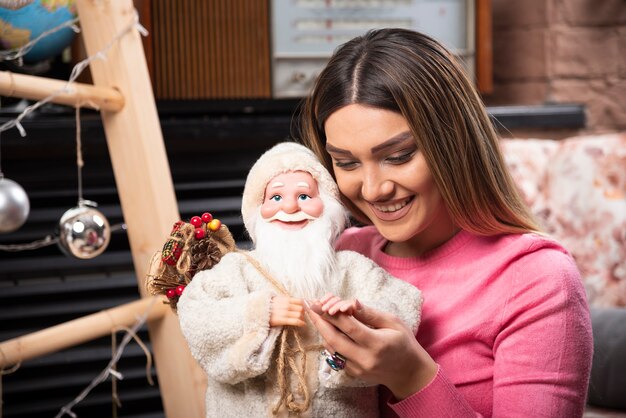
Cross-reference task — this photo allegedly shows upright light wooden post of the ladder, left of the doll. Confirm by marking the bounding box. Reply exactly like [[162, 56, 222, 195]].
[[76, 0, 206, 418]]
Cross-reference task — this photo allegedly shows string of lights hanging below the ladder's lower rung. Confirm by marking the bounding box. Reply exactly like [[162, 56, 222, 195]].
[[55, 298, 157, 418]]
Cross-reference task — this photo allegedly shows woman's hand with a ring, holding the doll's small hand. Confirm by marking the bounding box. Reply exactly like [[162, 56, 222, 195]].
[[307, 297, 438, 400]]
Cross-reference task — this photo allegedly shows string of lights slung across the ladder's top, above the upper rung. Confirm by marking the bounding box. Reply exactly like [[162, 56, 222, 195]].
[[0, 10, 148, 137]]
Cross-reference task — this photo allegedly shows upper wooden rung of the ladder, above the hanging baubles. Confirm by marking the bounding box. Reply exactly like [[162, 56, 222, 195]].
[[0, 71, 124, 112]]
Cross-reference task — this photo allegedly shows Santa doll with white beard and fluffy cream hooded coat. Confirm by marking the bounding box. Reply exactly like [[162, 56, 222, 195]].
[[151, 142, 422, 418]]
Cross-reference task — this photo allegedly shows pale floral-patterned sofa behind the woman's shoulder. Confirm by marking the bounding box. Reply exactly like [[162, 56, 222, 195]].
[[500, 133, 626, 418]]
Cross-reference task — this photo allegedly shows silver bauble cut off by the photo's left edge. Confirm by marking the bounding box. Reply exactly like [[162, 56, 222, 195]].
[[0, 174, 30, 234]]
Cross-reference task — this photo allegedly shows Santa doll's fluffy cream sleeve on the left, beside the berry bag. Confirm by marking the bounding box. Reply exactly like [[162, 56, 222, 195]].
[[178, 254, 279, 384]]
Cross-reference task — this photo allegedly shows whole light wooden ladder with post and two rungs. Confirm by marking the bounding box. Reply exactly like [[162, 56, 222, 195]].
[[0, 0, 206, 418]]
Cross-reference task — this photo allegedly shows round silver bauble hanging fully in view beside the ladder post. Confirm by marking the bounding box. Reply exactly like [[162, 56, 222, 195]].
[[59, 200, 111, 259]]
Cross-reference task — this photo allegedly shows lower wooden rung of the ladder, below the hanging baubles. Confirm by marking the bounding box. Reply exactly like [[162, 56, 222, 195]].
[[0, 296, 170, 369]]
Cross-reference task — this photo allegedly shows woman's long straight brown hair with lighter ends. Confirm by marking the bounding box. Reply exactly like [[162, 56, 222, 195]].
[[294, 29, 539, 235]]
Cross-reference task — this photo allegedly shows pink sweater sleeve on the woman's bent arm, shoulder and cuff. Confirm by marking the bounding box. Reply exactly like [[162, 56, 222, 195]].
[[388, 245, 593, 417]]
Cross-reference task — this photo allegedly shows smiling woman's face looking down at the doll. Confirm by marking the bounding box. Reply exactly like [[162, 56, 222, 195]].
[[324, 104, 457, 257]]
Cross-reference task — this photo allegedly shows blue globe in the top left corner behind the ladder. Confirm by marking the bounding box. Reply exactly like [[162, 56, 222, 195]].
[[0, 0, 76, 63]]
